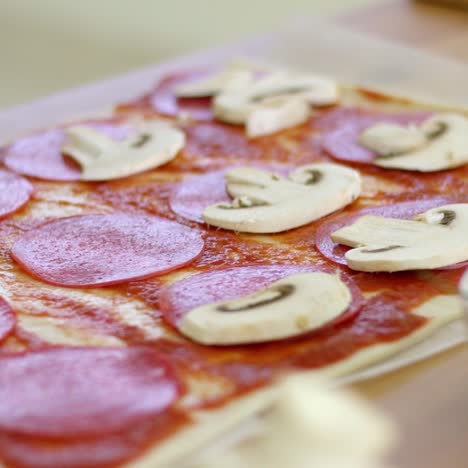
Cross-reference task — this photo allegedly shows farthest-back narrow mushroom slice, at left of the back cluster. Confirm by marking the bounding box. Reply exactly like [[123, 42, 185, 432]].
[[174, 61, 255, 98]]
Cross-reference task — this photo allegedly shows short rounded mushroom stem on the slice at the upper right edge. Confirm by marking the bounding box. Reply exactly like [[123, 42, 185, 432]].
[[359, 123, 426, 157]]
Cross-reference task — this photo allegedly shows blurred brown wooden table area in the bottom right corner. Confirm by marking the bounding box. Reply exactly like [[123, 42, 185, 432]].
[[354, 345, 468, 468]]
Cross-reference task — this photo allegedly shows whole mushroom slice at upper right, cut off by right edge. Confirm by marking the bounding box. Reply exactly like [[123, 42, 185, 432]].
[[359, 114, 468, 172]]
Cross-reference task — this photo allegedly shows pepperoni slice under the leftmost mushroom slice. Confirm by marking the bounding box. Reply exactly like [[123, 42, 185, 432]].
[[4, 122, 130, 182]]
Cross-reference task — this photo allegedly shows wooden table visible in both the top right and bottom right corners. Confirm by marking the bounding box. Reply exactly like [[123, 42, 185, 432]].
[[338, 0, 468, 468]]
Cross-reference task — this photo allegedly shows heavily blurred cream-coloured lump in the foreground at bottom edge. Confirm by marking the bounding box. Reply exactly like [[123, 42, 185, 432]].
[[196, 375, 396, 468]]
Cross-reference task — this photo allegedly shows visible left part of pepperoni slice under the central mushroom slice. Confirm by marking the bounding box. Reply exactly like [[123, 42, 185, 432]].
[[169, 171, 230, 223]]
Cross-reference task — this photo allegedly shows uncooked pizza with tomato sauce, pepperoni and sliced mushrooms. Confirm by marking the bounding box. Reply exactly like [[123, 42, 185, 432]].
[[0, 62, 468, 468]]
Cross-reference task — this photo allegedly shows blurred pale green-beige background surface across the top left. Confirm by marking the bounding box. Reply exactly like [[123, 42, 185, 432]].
[[0, 0, 374, 108]]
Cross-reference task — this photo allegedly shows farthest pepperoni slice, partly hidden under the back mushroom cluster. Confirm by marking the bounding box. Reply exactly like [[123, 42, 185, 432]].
[[150, 71, 213, 120]]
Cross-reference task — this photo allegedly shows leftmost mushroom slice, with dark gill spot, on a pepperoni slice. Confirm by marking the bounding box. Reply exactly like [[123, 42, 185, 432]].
[[62, 122, 185, 181]]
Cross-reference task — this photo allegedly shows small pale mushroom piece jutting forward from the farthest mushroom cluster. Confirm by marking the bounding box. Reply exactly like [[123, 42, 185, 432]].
[[246, 96, 310, 138]]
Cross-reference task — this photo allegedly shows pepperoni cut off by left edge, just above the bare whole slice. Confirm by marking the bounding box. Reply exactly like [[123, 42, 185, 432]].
[[0, 169, 34, 219]]
